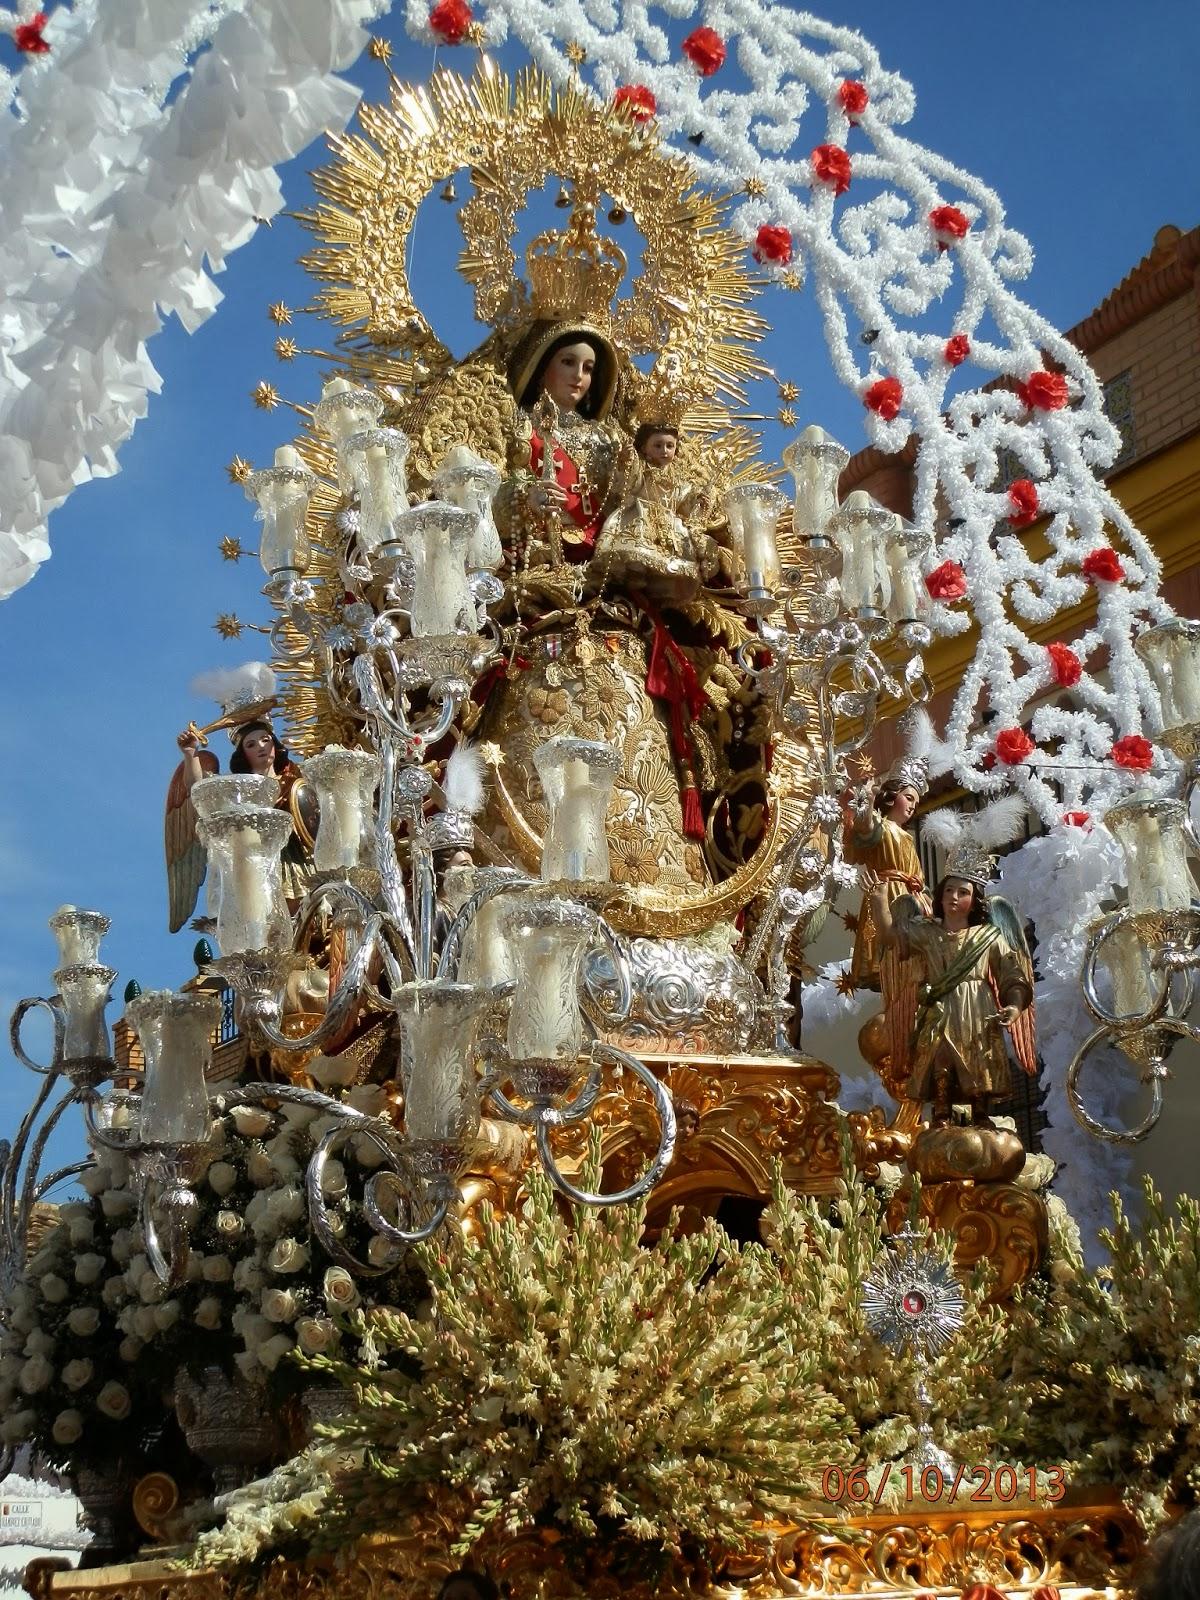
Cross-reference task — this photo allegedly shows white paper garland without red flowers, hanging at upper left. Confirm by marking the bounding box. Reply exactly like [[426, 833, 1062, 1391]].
[[0, 0, 387, 597]]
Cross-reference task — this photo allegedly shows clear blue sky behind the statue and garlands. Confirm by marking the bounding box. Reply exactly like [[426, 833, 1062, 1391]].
[[0, 0, 1200, 1158]]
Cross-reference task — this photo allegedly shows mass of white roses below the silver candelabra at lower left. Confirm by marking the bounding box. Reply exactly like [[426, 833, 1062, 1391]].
[[0, 1107, 418, 1467]]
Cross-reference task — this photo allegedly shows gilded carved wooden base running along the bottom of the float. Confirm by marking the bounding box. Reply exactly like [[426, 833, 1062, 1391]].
[[26, 1491, 1142, 1600]]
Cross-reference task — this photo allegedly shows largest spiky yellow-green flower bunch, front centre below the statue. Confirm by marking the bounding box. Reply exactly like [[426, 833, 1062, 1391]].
[[197, 1154, 851, 1560]]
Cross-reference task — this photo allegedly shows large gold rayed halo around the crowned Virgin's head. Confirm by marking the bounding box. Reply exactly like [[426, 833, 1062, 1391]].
[[299, 56, 766, 432]]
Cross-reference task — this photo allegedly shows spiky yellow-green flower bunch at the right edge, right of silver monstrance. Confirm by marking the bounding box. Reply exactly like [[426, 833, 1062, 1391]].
[[1005, 1178, 1200, 1526]]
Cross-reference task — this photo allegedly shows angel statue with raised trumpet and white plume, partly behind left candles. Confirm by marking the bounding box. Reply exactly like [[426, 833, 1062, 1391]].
[[163, 661, 315, 933]]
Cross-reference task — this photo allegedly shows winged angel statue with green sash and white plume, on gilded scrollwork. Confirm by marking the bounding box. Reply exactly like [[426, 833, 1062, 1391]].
[[864, 797, 1037, 1128]]
